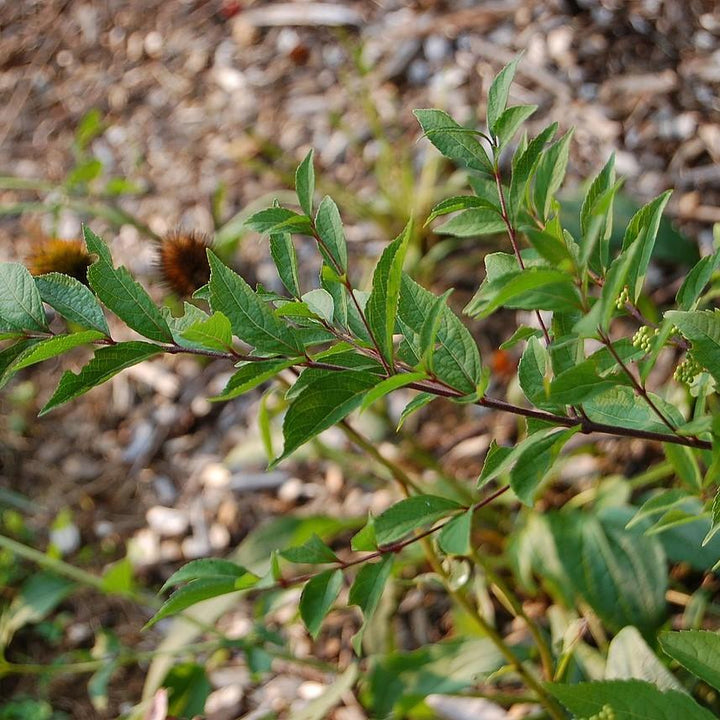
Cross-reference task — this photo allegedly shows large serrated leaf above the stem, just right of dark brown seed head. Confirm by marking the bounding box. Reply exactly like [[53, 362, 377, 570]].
[[208, 250, 303, 356]]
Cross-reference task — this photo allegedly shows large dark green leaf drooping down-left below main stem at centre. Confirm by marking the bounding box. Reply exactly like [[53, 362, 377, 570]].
[[275, 369, 378, 462]]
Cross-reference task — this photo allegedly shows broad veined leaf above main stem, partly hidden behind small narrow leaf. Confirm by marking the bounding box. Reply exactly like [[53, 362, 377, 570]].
[[398, 274, 482, 394]]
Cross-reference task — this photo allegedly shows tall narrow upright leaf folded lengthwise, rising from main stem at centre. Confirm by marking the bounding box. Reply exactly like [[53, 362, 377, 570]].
[[366, 222, 412, 367]]
